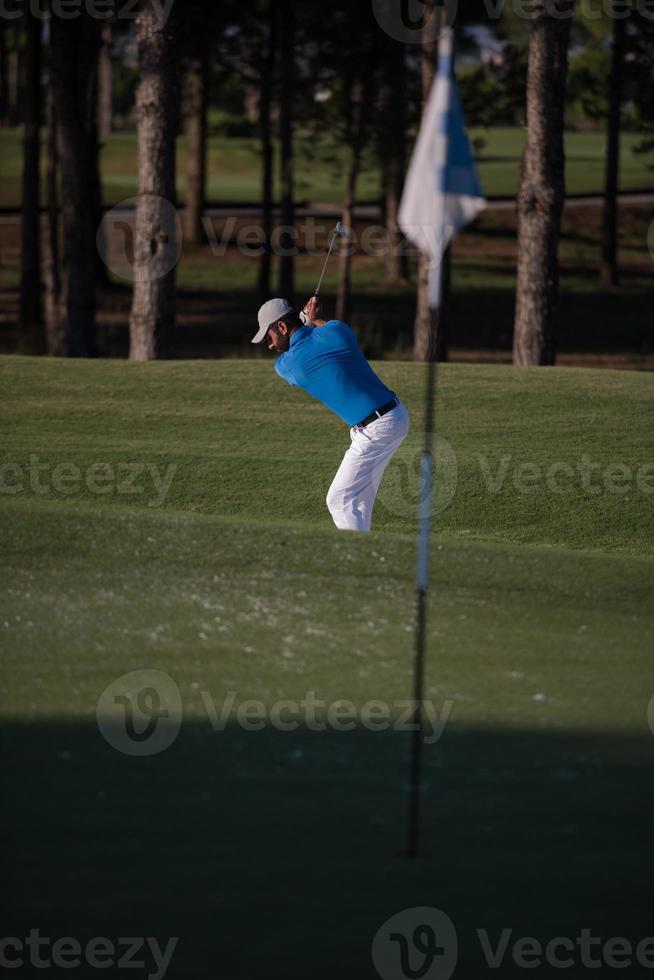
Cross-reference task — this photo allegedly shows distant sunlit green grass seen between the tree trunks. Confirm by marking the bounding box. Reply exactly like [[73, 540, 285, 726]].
[[0, 127, 654, 207]]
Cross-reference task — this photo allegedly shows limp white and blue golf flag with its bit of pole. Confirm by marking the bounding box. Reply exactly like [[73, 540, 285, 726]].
[[398, 30, 486, 309]]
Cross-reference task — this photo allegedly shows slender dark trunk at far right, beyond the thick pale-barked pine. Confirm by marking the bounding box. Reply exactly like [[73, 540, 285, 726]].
[[601, 14, 625, 286]]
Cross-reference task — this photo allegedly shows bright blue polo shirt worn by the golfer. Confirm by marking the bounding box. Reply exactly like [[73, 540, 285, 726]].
[[275, 320, 394, 425]]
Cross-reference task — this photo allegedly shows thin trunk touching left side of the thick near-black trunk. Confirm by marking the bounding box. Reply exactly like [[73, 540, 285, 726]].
[[44, 86, 67, 357]]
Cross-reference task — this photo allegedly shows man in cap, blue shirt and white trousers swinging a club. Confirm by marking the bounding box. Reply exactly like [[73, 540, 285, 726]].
[[252, 296, 409, 531]]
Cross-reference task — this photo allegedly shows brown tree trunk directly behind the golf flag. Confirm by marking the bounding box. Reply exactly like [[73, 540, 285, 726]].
[[413, 8, 449, 361]]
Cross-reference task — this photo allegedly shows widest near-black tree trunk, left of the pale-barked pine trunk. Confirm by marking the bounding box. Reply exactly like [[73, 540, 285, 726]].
[[50, 10, 101, 357]]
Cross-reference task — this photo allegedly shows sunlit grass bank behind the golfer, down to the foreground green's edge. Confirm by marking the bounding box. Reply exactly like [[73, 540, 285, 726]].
[[2, 355, 654, 553]]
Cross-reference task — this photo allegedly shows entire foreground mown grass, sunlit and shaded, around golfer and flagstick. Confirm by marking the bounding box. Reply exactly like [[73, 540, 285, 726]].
[[0, 357, 654, 980]]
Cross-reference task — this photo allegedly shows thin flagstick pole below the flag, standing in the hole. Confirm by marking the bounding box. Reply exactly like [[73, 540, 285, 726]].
[[406, 324, 436, 858]]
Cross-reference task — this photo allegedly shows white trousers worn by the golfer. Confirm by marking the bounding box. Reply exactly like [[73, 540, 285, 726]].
[[327, 402, 409, 531]]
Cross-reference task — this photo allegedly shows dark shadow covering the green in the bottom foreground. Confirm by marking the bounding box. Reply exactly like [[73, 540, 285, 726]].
[[1, 723, 653, 980]]
